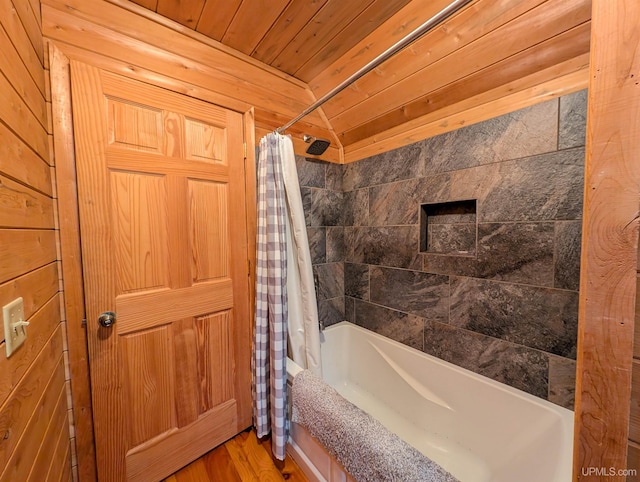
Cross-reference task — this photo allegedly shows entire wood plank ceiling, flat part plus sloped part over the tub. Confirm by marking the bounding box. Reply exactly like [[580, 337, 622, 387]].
[[121, 0, 591, 160]]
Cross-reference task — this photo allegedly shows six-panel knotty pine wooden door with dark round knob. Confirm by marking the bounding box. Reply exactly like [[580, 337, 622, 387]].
[[71, 62, 251, 481]]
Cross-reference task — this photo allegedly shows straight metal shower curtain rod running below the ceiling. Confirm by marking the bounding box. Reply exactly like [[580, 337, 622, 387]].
[[276, 0, 471, 134]]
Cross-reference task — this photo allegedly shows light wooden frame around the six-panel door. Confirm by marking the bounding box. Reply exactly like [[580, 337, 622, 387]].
[[48, 41, 256, 482]]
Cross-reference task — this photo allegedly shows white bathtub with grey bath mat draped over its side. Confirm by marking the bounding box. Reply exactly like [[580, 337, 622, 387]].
[[288, 322, 573, 482]]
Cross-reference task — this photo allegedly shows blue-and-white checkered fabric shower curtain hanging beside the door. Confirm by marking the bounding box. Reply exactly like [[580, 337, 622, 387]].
[[252, 133, 291, 460]]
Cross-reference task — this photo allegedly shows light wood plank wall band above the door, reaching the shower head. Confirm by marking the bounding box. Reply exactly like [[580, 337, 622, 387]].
[[42, 0, 342, 162]]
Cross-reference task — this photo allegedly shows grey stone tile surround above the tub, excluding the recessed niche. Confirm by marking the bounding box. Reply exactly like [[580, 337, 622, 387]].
[[298, 91, 586, 408]]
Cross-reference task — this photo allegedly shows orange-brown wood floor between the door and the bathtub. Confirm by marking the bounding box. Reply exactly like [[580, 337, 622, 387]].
[[164, 430, 308, 482]]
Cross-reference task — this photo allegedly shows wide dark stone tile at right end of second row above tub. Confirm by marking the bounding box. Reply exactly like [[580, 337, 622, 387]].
[[448, 278, 578, 358]]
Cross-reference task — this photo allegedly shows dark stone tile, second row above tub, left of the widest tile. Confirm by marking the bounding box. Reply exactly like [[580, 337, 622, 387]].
[[369, 267, 449, 321]]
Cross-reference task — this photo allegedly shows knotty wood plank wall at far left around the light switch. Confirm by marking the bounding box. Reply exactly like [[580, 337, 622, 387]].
[[0, 0, 71, 482]]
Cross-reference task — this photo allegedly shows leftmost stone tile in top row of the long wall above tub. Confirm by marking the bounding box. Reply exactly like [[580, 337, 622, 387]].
[[342, 143, 424, 191]]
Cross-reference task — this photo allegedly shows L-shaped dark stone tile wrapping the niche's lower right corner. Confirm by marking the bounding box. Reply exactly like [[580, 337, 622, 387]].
[[423, 222, 554, 286]]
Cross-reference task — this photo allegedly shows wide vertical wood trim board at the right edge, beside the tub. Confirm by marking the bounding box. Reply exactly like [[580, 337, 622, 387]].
[[574, 0, 640, 482]]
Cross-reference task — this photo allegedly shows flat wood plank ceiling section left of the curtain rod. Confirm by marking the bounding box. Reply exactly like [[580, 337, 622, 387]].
[[131, 0, 409, 82]]
